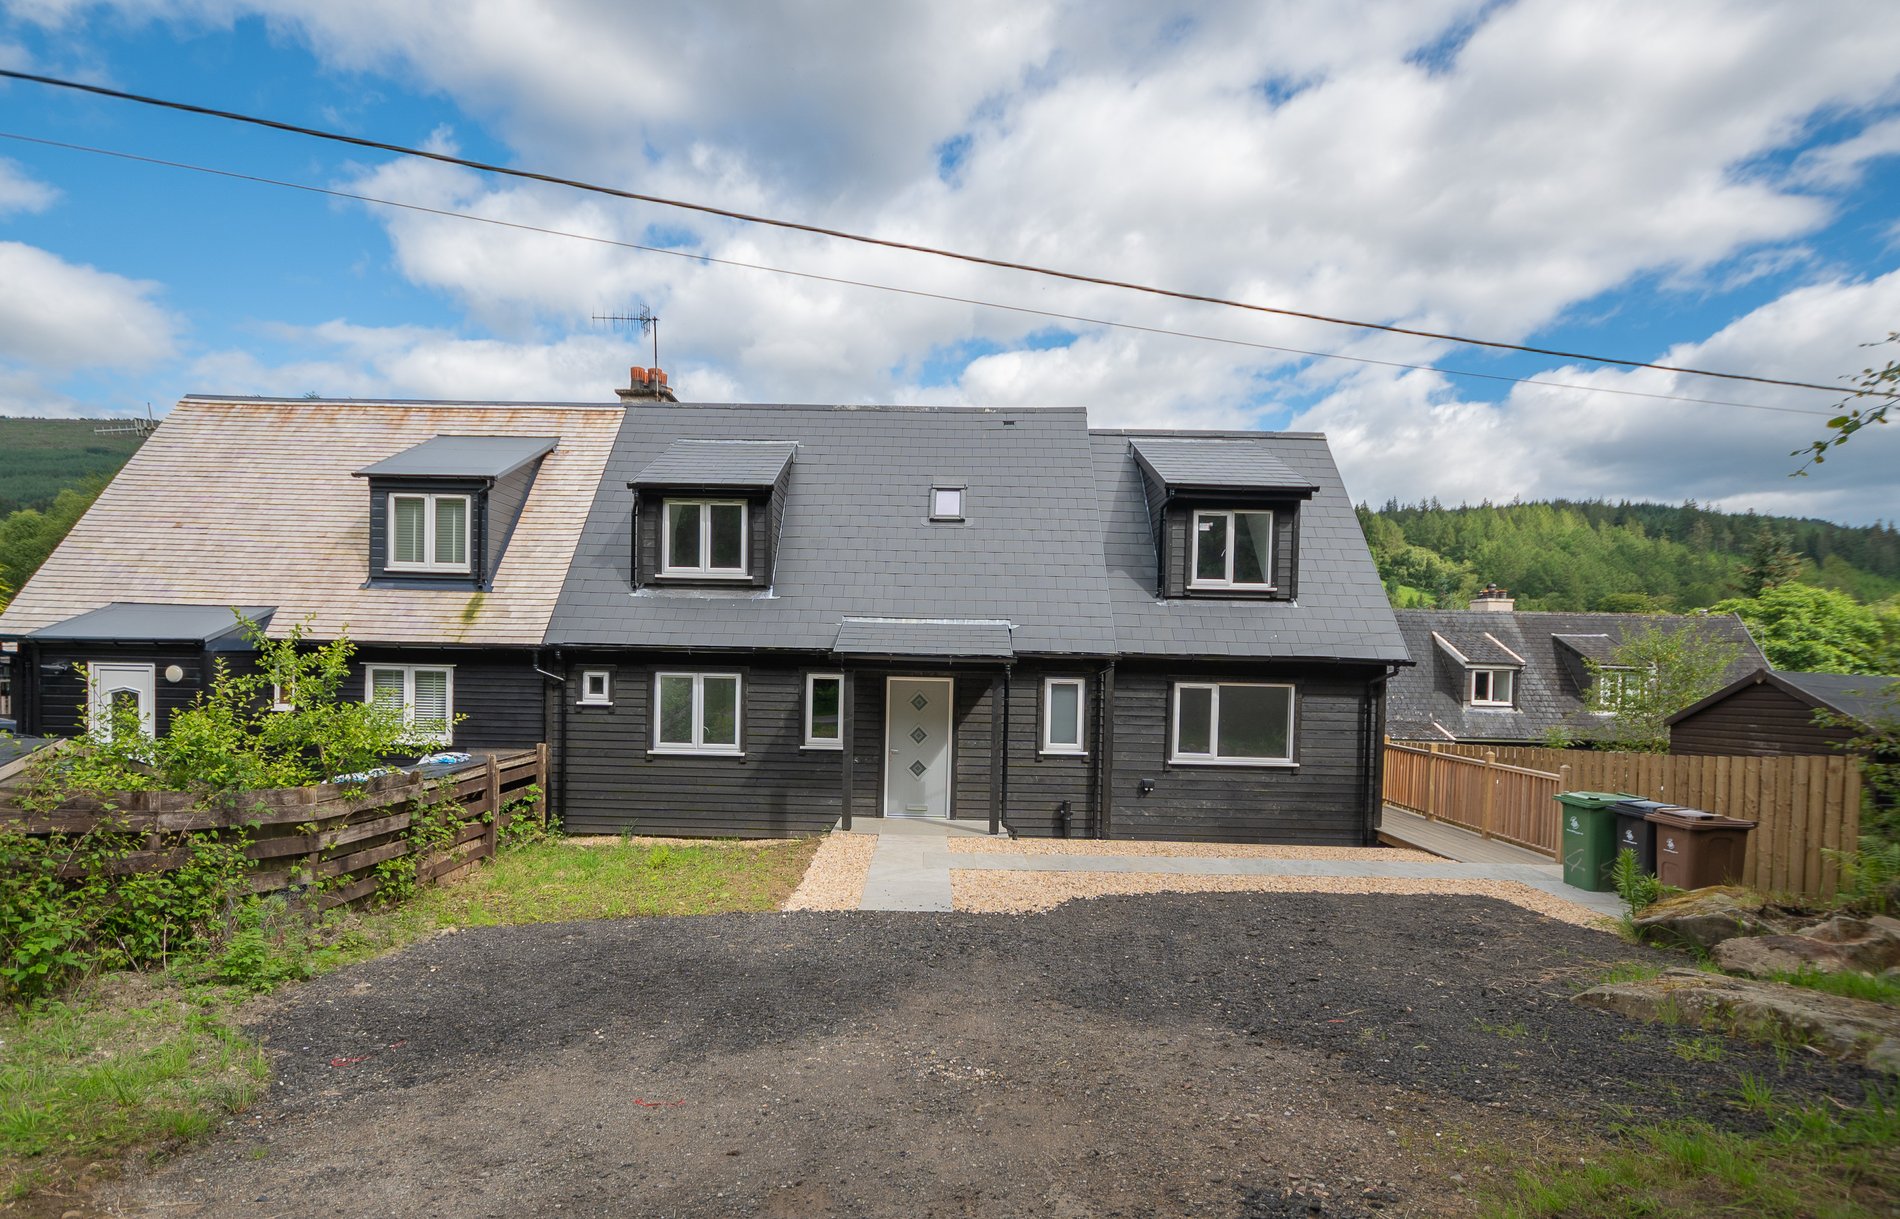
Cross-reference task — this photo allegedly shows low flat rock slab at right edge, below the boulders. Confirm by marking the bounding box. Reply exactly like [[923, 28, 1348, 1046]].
[[1577, 968, 1900, 1073]]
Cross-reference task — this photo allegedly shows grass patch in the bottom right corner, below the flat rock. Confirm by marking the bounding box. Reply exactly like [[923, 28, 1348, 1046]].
[[1484, 1078, 1900, 1219]]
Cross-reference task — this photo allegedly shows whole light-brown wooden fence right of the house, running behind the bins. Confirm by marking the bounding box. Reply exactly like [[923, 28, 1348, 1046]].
[[1385, 744, 1860, 898]]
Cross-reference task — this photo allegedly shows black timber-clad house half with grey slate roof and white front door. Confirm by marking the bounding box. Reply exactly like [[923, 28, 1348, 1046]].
[[547, 403, 1406, 843]]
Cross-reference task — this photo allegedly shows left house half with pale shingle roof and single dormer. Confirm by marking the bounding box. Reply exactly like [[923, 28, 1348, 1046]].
[[0, 397, 621, 748]]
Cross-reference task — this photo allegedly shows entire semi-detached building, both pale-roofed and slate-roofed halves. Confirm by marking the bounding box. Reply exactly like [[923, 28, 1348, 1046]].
[[0, 370, 1408, 845]]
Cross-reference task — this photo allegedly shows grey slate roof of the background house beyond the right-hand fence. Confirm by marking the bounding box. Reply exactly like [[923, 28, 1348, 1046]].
[[1385, 610, 1763, 744]]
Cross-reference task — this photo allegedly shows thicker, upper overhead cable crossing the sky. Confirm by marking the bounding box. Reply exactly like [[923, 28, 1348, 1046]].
[[0, 68, 1900, 397]]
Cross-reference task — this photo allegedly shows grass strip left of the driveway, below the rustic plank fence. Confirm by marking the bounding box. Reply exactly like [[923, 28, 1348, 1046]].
[[0, 839, 817, 1206]]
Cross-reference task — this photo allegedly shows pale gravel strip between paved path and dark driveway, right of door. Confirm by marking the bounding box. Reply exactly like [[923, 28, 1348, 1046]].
[[950, 868, 1609, 932]]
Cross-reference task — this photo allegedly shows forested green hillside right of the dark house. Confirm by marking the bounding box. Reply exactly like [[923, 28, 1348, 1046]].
[[1359, 499, 1900, 611]]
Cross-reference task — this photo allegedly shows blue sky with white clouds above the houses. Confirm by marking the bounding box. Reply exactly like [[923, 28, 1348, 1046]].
[[0, 0, 1900, 520]]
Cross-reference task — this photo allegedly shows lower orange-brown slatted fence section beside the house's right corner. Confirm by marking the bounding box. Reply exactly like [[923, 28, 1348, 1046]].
[[1385, 742, 1562, 858]]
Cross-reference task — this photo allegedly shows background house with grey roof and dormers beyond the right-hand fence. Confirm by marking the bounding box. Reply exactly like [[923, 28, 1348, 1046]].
[[1385, 585, 1765, 744]]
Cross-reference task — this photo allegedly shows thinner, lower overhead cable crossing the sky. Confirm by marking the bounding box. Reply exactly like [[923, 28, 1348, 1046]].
[[0, 131, 1834, 418]]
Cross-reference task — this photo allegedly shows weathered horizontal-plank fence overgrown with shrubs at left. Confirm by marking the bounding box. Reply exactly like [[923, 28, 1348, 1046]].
[[0, 744, 547, 908]]
